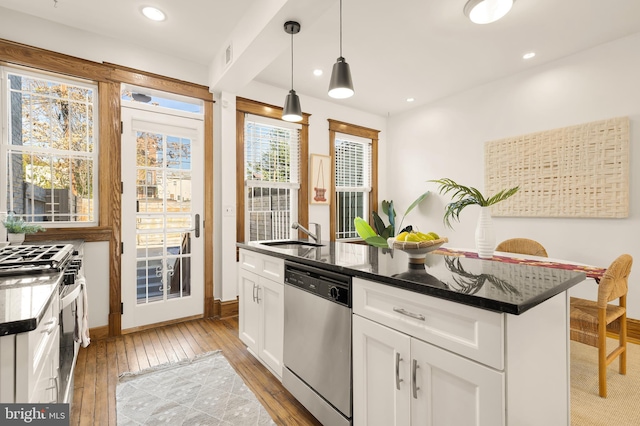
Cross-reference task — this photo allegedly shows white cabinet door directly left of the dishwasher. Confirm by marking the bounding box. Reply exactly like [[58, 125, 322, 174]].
[[257, 278, 284, 378]]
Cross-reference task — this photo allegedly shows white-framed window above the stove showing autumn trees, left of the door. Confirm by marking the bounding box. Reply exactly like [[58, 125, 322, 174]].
[[0, 68, 98, 226]]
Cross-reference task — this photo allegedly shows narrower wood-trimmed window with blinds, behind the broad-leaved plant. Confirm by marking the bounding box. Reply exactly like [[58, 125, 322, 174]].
[[329, 120, 378, 240]]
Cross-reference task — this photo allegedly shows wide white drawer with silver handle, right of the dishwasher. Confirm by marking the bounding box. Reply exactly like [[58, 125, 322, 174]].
[[352, 278, 504, 370]]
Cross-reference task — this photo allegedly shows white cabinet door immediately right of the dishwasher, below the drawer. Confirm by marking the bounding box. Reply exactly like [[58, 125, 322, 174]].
[[353, 315, 410, 426]]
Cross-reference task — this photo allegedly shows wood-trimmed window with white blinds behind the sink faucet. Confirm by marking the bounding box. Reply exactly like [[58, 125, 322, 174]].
[[236, 97, 309, 242]]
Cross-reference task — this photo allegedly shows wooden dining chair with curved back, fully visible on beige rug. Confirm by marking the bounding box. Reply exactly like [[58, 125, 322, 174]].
[[570, 254, 633, 398]]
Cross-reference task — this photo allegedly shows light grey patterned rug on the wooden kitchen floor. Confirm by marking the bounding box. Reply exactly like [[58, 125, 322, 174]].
[[116, 351, 275, 426]]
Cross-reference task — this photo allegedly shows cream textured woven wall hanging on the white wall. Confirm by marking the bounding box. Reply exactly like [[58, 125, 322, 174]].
[[485, 117, 629, 218]]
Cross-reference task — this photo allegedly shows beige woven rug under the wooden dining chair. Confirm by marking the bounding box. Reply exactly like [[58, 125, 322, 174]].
[[571, 338, 640, 426]]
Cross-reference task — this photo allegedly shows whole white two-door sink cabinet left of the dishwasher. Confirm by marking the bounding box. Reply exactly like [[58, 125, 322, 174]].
[[238, 250, 284, 378]]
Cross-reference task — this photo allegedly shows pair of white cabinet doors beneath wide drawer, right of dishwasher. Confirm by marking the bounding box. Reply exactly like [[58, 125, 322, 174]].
[[353, 315, 504, 426]]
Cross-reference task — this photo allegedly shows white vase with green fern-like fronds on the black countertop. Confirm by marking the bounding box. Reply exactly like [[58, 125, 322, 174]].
[[429, 178, 520, 258]]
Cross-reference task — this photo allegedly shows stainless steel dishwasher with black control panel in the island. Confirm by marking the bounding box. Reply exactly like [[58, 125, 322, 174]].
[[282, 261, 352, 426]]
